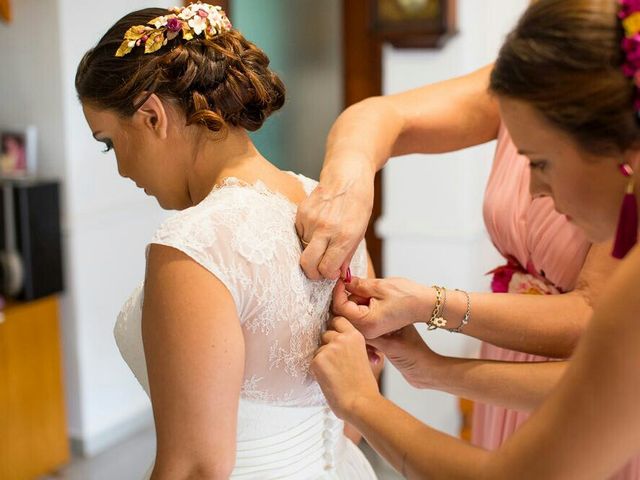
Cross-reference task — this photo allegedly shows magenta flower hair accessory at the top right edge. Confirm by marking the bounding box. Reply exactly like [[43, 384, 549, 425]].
[[618, 0, 640, 111]]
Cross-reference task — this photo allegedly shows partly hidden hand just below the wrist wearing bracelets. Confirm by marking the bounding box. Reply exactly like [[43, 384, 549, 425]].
[[367, 325, 447, 388]]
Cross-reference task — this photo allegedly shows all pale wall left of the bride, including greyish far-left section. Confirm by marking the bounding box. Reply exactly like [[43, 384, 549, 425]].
[[0, 0, 175, 454]]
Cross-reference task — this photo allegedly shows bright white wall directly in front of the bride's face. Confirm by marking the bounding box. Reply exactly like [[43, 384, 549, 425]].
[[58, 0, 175, 454]]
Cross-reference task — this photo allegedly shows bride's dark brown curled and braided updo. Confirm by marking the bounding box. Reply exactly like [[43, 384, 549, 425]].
[[75, 4, 285, 132]]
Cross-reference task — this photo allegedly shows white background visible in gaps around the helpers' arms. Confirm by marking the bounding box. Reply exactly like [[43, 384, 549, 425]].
[[377, 0, 528, 434]]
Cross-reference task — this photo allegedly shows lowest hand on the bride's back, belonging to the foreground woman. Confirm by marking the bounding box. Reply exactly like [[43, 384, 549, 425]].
[[311, 317, 380, 419]]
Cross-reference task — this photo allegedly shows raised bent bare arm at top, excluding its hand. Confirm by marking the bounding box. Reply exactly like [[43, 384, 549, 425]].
[[323, 66, 500, 180]]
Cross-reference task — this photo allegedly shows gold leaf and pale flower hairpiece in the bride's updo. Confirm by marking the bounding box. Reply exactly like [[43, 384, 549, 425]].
[[115, 2, 232, 57]]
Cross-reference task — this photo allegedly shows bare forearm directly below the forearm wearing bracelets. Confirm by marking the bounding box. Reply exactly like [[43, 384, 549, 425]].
[[422, 357, 566, 412]]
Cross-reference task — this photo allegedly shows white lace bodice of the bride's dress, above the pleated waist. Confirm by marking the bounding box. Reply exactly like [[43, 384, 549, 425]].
[[114, 175, 367, 406]]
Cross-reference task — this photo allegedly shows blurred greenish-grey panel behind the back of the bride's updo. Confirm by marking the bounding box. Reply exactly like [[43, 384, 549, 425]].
[[231, 0, 344, 178]]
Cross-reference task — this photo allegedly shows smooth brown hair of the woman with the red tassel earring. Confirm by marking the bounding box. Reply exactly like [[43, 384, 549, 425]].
[[490, 0, 640, 155]]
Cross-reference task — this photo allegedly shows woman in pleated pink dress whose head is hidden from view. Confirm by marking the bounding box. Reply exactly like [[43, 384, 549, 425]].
[[297, 23, 640, 479]]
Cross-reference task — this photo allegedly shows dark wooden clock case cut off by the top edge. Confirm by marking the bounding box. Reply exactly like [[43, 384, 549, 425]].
[[370, 0, 457, 48]]
